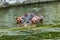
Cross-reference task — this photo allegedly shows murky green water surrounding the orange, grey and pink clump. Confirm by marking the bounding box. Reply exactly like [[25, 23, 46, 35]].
[[0, 2, 60, 40]]
